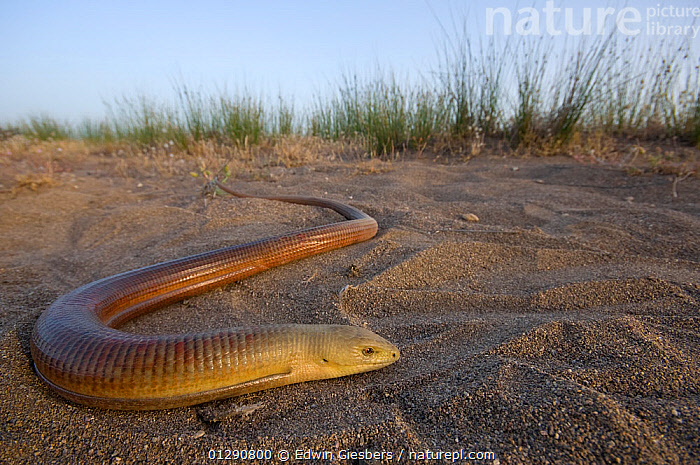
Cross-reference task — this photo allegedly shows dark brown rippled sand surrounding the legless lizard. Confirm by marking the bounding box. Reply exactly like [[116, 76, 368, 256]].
[[0, 151, 700, 464]]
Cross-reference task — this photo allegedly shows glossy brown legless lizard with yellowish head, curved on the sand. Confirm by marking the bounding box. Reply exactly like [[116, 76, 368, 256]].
[[31, 182, 399, 410]]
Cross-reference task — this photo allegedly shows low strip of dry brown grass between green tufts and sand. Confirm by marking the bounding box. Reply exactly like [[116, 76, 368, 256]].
[[0, 131, 700, 196]]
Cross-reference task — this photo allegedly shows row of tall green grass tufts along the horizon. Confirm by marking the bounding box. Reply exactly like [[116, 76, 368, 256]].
[[6, 16, 700, 157]]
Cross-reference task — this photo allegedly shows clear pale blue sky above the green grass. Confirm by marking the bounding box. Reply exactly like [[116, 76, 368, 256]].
[[0, 0, 700, 124]]
